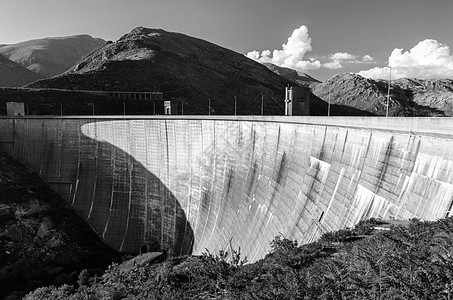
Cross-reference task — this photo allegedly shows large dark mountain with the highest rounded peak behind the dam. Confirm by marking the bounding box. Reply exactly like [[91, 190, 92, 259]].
[[29, 27, 306, 114]]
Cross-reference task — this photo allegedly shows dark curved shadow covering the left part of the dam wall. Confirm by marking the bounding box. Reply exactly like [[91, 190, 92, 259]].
[[3, 119, 194, 256]]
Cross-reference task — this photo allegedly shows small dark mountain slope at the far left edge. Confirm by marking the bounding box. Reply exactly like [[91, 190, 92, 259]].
[[0, 54, 43, 87]]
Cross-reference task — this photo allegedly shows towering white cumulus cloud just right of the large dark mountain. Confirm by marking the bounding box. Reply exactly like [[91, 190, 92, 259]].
[[246, 25, 321, 71]]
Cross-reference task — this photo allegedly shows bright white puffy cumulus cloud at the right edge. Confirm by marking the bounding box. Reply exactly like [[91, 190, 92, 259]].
[[359, 39, 453, 79]]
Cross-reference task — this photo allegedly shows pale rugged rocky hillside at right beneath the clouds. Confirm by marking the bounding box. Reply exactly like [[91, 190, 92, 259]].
[[311, 73, 453, 116]]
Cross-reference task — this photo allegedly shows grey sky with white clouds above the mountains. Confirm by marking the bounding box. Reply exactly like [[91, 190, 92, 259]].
[[0, 0, 453, 81]]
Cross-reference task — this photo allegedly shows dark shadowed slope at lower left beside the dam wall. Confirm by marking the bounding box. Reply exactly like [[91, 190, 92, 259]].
[[0, 151, 121, 299]]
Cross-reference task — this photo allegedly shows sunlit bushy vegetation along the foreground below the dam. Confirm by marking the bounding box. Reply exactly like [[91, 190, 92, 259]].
[[25, 218, 453, 300]]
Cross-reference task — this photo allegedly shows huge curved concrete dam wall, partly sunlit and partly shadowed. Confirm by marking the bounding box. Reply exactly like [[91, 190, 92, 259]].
[[0, 116, 453, 261]]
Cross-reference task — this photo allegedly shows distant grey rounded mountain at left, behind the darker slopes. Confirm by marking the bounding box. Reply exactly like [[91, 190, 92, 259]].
[[0, 35, 105, 77]]
